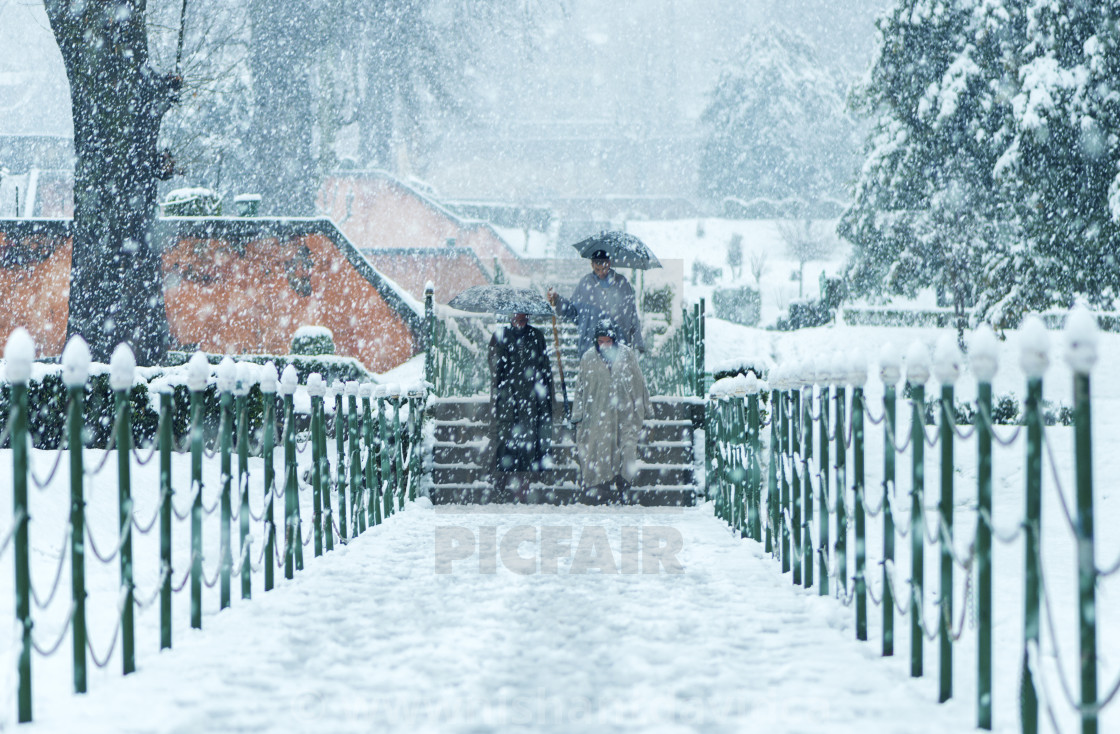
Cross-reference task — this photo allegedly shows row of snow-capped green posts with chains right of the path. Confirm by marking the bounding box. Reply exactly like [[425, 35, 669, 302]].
[[708, 308, 1120, 732]]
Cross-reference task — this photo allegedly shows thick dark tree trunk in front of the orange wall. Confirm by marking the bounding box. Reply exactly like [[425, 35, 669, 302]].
[[46, 0, 181, 364]]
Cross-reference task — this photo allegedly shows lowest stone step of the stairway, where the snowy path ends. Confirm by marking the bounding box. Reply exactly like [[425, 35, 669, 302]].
[[429, 484, 697, 507]]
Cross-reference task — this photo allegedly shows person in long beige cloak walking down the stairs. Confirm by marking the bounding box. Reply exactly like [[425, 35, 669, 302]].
[[571, 319, 650, 500]]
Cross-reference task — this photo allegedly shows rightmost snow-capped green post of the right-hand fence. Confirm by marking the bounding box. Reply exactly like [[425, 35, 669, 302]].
[[1065, 306, 1099, 734]]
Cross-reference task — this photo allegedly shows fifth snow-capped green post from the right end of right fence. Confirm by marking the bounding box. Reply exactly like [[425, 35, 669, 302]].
[[906, 342, 930, 678]]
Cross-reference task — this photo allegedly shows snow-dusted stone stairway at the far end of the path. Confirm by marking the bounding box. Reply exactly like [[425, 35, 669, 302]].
[[429, 396, 703, 505]]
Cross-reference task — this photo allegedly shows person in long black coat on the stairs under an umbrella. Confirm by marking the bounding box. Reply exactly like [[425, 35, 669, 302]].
[[489, 314, 552, 492]]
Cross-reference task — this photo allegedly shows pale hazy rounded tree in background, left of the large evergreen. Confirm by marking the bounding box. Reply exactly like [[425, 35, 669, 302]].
[[700, 26, 855, 212]]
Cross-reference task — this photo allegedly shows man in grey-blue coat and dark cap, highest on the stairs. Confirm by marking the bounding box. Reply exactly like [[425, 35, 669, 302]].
[[548, 250, 645, 355]]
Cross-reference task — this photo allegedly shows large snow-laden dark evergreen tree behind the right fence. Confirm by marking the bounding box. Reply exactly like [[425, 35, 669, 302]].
[[840, 0, 1120, 325]]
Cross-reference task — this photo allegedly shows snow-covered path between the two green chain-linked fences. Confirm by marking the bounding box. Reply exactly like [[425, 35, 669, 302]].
[[20, 500, 972, 734]]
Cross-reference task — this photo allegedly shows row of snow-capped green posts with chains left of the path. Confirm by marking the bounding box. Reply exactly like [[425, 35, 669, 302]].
[[0, 328, 426, 722]]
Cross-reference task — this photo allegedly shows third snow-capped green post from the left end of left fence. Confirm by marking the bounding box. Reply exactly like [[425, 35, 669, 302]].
[[109, 344, 137, 676]]
